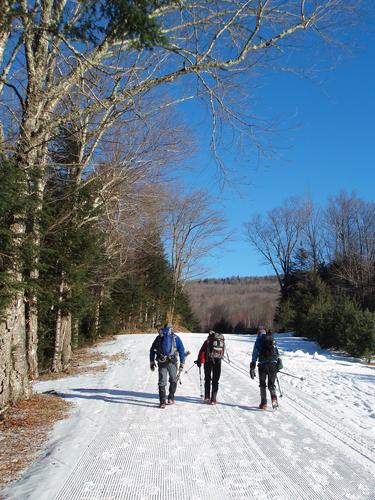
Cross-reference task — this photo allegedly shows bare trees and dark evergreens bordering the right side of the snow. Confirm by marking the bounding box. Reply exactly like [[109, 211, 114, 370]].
[[247, 193, 375, 359]]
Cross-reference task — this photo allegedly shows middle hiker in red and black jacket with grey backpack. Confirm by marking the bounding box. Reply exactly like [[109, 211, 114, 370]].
[[195, 330, 225, 405]]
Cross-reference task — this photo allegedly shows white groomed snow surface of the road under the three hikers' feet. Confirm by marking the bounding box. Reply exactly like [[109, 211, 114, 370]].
[[4, 334, 375, 500]]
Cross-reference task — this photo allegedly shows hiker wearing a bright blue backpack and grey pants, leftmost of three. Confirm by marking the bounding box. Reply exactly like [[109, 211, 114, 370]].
[[150, 323, 185, 408]]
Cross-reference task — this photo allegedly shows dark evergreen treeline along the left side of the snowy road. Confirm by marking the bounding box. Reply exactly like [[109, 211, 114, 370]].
[[0, 151, 198, 368]]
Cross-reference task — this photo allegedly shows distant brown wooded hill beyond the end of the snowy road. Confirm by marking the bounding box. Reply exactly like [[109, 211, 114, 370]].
[[186, 276, 279, 333]]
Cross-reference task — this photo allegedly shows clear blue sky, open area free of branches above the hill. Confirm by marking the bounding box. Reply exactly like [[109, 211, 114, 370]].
[[178, 17, 375, 277]]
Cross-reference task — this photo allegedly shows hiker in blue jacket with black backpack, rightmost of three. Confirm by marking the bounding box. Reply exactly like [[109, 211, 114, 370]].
[[250, 326, 279, 410]]
